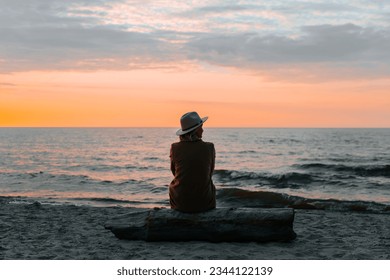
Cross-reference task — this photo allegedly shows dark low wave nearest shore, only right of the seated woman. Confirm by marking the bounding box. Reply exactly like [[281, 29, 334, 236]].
[[217, 188, 390, 213]]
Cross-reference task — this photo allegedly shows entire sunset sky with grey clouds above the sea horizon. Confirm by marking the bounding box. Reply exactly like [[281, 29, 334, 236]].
[[0, 0, 390, 127]]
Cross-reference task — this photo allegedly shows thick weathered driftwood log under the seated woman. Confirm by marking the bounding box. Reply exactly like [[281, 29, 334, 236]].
[[105, 208, 296, 242]]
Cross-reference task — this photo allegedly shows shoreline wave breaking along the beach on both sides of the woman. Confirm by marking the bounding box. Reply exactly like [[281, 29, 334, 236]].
[[0, 188, 390, 214]]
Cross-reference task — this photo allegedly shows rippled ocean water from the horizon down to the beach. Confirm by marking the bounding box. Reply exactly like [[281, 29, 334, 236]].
[[0, 127, 390, 213]]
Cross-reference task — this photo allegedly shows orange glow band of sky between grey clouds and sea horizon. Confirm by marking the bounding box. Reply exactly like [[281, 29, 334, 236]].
[[0, 70, 390, 127]]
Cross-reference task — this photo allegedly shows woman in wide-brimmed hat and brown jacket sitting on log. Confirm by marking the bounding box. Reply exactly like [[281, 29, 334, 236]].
[[169, 112, 216, 213]]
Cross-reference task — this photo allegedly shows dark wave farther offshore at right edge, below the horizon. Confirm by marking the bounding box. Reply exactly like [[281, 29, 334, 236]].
[[295, 163, 390, 177]]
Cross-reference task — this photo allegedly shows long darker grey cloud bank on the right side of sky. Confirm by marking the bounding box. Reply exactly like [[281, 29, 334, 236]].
[[187, 24, 390, 80]]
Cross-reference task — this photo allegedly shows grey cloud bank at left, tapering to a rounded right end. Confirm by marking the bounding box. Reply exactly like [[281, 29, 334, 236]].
[[0, 27, 174, 71]]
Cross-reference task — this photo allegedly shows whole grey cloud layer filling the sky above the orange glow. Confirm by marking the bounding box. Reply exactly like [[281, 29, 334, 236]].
[[0, 0, 390, 80]]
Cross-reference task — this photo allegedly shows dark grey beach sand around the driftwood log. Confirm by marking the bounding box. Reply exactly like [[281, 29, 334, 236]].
[[0, 203, 390, 260]]
